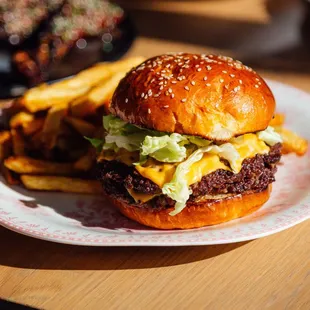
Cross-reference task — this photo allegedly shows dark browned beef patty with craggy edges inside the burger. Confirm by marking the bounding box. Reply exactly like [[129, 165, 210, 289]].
[[98, 143, 281, 209]]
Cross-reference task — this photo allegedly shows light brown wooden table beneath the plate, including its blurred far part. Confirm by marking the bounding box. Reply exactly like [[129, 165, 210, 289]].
[[0, 0, 310, 310]]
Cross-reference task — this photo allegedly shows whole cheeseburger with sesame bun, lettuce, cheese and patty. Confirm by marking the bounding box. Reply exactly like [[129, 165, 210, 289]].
[[88, 53, 281, 229]]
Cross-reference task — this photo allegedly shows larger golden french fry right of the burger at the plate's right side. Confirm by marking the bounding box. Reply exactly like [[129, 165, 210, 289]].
[[275, 127, 308, 156]]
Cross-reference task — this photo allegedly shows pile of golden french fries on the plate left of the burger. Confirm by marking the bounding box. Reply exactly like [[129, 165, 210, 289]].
[[0, 57, 144, 194]]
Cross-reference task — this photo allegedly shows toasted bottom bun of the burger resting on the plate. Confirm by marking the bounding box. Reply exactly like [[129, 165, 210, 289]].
[[109, 185, 271, 229]]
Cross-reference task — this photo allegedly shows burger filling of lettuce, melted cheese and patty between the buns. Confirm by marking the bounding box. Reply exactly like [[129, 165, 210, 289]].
[[90, 115, 281, 215]]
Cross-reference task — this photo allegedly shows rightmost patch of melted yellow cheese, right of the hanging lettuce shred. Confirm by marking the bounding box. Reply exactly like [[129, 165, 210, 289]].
[[229, 133, 269, 172]]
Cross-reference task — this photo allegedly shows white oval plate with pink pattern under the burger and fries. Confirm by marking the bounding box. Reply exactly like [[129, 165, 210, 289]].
[[0, 81, 310, 246]]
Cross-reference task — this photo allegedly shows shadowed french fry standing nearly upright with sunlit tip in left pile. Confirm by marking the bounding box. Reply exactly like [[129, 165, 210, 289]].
[[41, 102, 68, 150]]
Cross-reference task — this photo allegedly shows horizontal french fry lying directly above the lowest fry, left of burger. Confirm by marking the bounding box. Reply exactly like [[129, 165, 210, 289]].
[[4, 156, 76, 175]]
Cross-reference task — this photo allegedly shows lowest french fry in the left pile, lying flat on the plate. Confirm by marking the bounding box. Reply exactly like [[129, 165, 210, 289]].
[[21, 175, 102, 195]]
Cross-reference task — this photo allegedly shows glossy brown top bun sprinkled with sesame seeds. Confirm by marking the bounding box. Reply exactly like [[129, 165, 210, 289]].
[[110, 53, 275, 141]]
